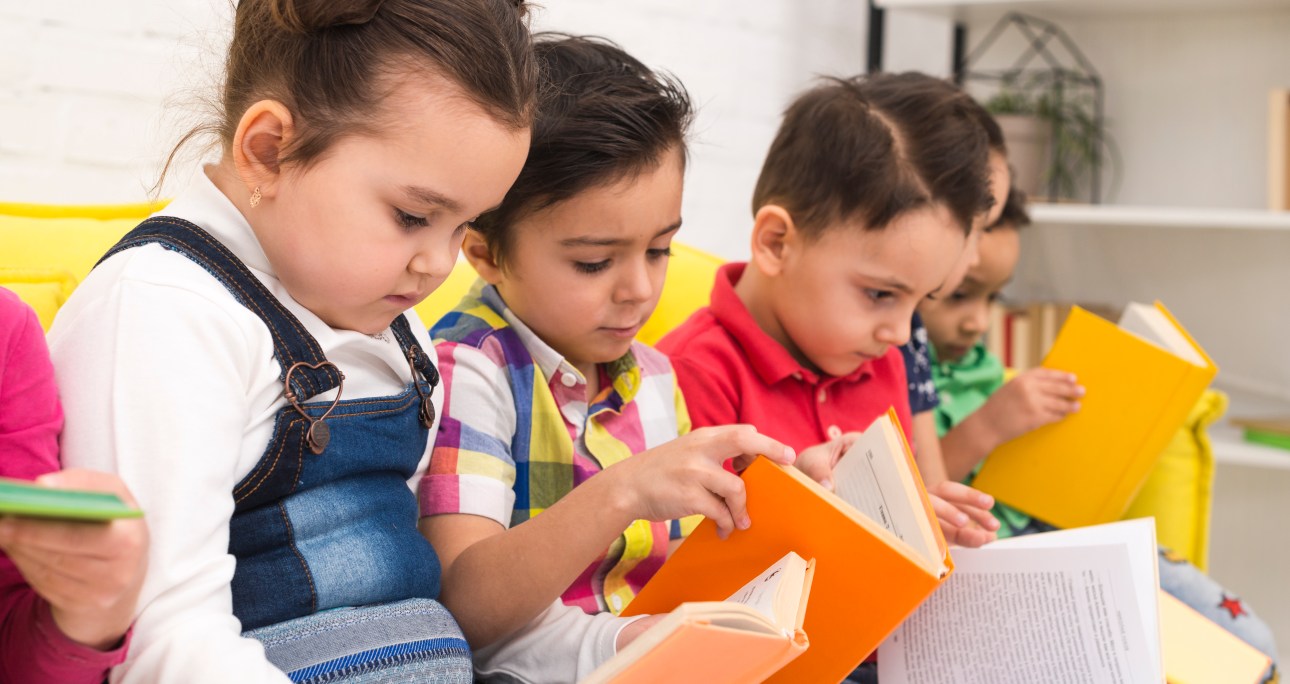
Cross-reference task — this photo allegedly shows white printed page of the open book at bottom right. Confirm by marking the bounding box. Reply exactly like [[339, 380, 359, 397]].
[[878, 545, 1160, 684]]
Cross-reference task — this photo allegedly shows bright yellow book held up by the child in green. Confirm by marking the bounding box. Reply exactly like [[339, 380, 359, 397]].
[[973, 302, 1218, 528]]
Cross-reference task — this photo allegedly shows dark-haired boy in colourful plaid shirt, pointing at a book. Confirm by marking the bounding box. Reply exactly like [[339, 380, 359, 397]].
[[421, 35, 793, 683]]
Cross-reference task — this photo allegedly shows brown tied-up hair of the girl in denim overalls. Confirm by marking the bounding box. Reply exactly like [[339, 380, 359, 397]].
[[159, 0, 537, 180]]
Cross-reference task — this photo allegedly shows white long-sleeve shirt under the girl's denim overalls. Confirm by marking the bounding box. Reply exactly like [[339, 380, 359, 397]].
[[49, 167, 442, 683]]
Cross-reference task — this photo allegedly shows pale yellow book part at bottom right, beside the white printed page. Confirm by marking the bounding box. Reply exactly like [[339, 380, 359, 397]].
[[1160, 591, 1272, 684]]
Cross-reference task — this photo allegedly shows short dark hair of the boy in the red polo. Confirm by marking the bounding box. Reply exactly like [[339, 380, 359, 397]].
[[752, 72, 1002, 237]]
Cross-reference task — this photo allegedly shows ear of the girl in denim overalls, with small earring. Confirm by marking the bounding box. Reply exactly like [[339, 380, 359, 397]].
[[232, 99, 295, 199]]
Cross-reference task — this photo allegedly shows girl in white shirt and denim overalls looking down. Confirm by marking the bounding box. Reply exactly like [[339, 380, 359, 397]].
[[50, 0, 535, 683]]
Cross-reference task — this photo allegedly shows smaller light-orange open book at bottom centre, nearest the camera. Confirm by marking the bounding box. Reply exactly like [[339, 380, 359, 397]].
[[582, 552, 815, 684]]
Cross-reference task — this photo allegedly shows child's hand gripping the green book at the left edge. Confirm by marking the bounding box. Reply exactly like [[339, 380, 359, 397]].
[[0, 468, 148, 650]]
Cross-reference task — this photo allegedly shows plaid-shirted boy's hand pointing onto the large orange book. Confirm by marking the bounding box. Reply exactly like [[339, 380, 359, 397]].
[[602, 425, 796, 538]]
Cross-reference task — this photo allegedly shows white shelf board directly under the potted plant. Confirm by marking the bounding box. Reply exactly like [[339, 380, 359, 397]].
[[1029, 203, 1290, 231]]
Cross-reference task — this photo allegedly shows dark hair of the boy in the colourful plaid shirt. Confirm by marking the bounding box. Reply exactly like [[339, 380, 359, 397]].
[[475, 32, 694, 265]]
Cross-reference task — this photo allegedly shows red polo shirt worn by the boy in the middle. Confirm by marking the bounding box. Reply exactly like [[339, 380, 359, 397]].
[[658, 263, 913, 452]]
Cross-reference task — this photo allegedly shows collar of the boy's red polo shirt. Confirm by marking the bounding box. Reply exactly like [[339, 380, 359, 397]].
[[708, 262, 873, 385]]
